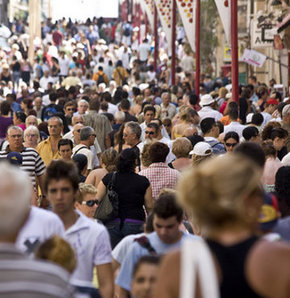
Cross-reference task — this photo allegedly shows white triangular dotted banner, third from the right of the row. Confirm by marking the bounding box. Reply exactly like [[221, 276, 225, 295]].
[[155, 0, 175, 51]]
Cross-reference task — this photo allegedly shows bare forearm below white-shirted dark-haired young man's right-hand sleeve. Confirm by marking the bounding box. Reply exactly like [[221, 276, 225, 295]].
[[96, 263, 114, 298]]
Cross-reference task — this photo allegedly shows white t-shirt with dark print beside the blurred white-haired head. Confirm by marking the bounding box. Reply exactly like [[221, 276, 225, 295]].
[[16, 206, 64, 253]]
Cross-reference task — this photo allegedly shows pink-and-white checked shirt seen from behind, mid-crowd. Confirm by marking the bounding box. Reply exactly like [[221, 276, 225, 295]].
[[139, 162, 180, 200]]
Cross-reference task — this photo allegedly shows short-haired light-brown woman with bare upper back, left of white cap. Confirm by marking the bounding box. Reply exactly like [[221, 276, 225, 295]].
[[168, 137, 192, 171]]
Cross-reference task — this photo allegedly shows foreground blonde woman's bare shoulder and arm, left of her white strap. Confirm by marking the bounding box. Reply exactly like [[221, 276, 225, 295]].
[[154, 251, 181, 298]]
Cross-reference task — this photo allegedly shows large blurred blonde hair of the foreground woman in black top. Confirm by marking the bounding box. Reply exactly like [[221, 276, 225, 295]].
[[178, 154, 261, 230]]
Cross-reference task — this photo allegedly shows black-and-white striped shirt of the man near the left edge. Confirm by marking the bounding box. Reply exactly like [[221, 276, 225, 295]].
[[0, 146, 45, 186]]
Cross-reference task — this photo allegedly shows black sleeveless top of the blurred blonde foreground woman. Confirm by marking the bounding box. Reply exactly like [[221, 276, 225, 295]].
[[206, 236, 261, 298]]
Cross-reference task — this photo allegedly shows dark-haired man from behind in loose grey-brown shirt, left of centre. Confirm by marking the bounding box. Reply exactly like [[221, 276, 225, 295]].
[[83, 99, 112, 151]]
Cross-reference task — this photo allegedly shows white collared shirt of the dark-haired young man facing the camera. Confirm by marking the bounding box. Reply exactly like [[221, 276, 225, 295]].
[[65, 210, 112, 281]]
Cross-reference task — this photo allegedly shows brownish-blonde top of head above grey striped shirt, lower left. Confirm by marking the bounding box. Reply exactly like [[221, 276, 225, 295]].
[[35, 236, 77, 273]]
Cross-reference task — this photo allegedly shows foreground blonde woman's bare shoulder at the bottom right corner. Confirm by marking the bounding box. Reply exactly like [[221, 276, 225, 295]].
[[246, 240, 290, 298]]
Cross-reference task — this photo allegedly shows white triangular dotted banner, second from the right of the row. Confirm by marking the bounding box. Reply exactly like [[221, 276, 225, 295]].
[[176, 0, 196, 52]]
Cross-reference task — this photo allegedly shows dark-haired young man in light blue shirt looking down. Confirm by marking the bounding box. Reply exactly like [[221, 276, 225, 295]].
[[116, 194, 192, 298]]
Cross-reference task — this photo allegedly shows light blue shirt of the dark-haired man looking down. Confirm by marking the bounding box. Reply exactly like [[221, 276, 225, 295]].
[[116, 232, 198, 291]]
